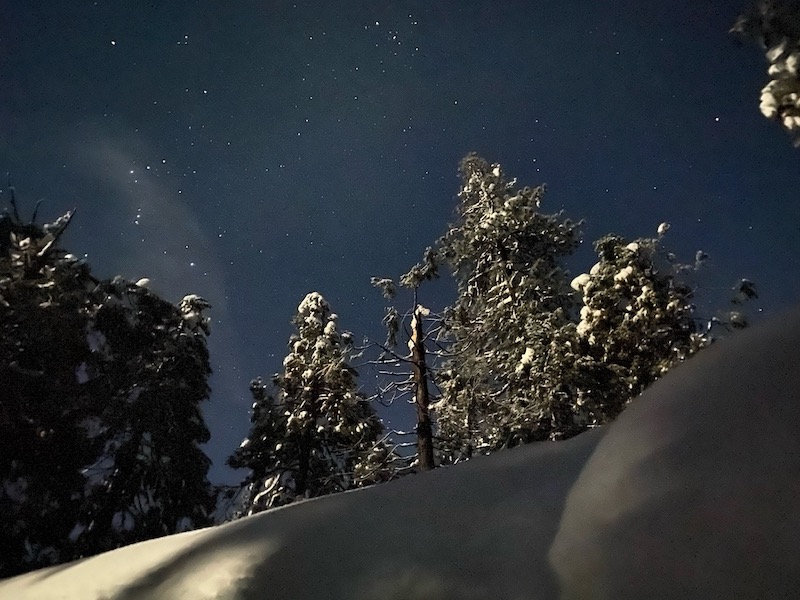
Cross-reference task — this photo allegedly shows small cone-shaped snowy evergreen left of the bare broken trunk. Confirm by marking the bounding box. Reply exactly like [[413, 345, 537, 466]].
[[229, 292, 390, 514]]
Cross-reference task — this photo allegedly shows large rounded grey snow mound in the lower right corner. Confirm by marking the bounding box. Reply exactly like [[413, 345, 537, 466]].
[[550, 311, 800, 598]]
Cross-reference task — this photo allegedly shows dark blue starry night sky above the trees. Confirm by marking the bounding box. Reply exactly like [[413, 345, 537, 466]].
[[0, 0, 800, 483]]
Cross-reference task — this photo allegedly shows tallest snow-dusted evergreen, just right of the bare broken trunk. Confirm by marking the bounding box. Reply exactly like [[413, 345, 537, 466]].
[[435, 154, 580, 460]]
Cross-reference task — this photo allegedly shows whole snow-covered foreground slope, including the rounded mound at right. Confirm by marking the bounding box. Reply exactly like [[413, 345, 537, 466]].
[[0, 310, 800, 600]]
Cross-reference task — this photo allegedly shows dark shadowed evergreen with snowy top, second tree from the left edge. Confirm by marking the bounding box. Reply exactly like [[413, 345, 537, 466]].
[[72, 288, 212, 552]]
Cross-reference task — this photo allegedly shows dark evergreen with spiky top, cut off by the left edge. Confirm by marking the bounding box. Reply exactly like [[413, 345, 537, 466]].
[[0, 207, 94, 577]]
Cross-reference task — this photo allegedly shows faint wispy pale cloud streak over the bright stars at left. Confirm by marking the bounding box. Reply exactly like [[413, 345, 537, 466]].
[[75, 127, 247, 476]]
